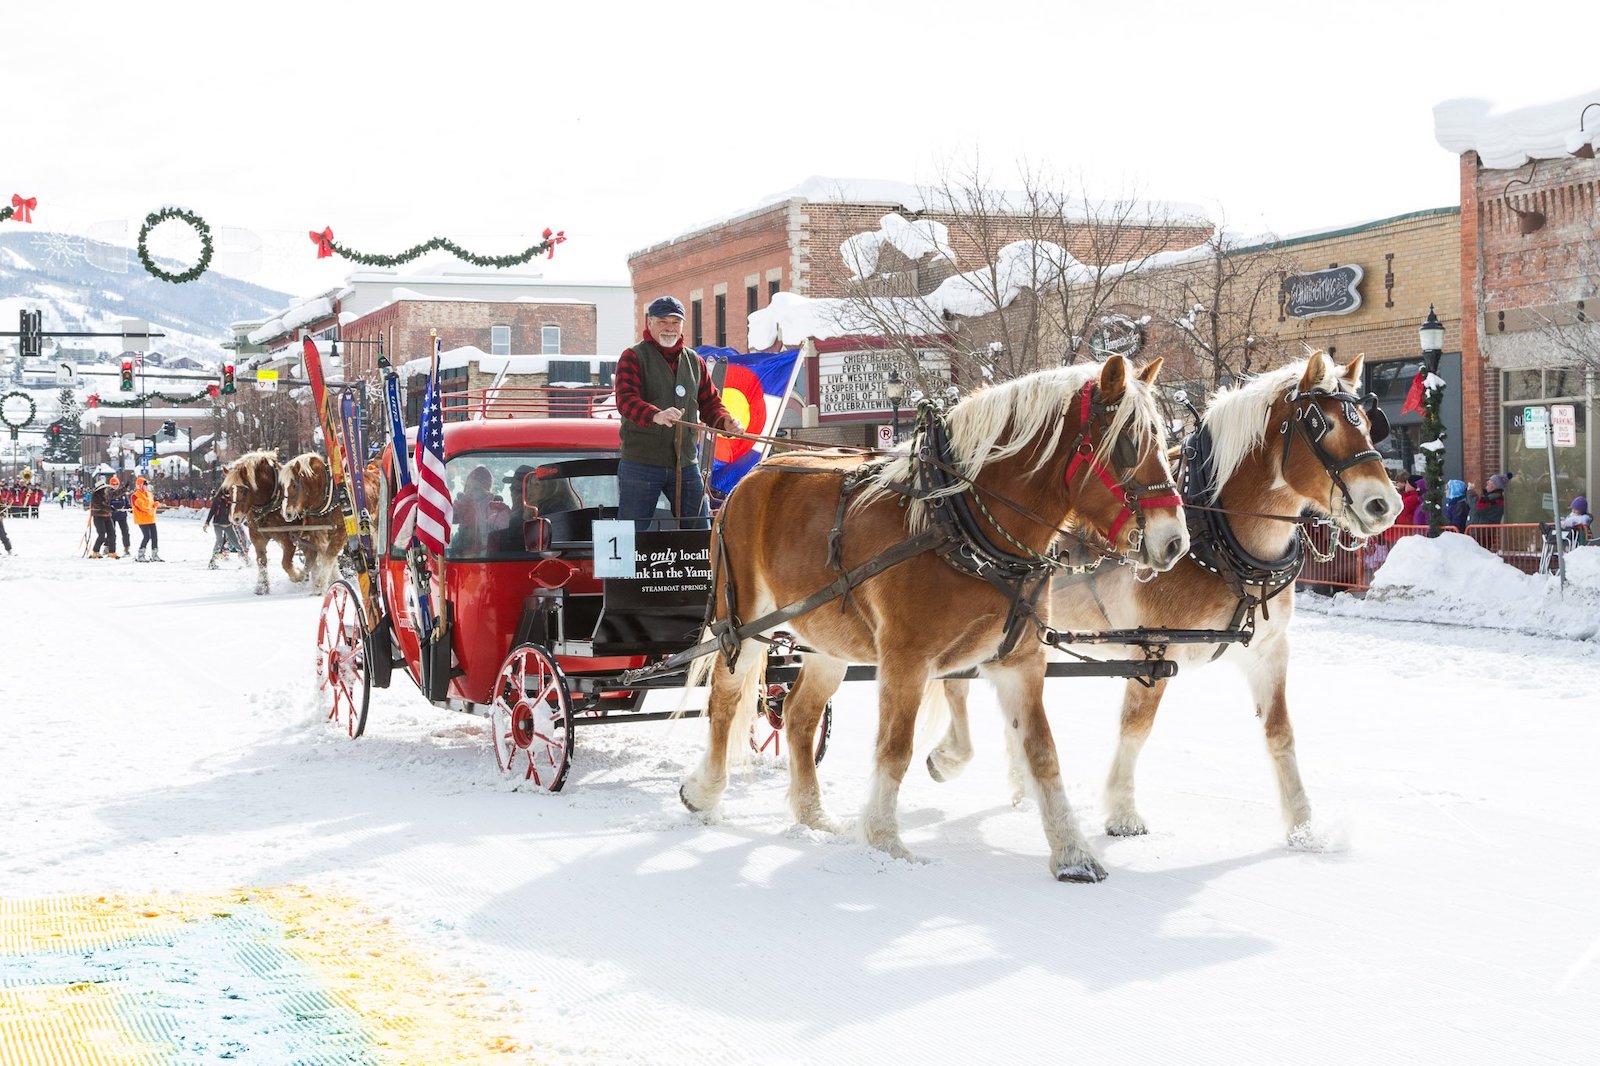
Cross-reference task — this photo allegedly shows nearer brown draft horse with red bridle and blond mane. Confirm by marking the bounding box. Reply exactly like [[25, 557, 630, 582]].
[[678, 355, 1189, 882]]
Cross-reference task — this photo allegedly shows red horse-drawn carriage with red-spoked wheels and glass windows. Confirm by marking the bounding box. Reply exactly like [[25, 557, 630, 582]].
[[317, 418, 829, 791]]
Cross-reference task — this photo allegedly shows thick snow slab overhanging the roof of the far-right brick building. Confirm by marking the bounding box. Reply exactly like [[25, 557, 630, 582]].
[[1434, 90, 1600, 170]]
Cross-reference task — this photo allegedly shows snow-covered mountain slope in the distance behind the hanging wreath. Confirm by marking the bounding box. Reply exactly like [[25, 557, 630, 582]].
[[0, 226, 290, 367]]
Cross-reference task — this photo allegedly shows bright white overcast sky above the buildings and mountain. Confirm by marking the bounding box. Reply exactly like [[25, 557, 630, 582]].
[[12, 0, 1600, 295]]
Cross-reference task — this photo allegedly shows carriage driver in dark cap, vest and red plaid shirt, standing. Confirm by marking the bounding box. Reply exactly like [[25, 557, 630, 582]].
[[616, 296, 744, 528]]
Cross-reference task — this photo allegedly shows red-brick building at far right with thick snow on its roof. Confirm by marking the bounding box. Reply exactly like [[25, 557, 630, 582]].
[[1435, 93, 1600, 522]]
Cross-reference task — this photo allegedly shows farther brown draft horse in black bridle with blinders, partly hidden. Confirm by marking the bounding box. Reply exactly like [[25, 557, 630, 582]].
[[928, 352, 1400, 847]]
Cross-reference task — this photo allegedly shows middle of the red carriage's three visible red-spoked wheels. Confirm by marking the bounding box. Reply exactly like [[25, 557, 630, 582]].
[[490, 643, 573, 792]]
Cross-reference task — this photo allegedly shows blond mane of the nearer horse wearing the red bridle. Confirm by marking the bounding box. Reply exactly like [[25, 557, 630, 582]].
[[853, 363, 1165, 533]]
